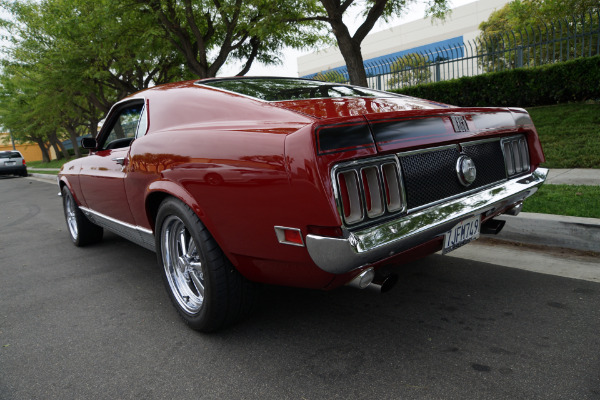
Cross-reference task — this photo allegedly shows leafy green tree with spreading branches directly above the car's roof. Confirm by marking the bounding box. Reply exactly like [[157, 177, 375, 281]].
[[137, 0, 323, 78]]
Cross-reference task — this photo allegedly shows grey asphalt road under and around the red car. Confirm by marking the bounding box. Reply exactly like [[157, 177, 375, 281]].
[[0, 177, 600, 400]]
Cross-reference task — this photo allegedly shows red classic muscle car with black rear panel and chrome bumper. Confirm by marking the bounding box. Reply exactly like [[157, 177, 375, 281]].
[[58, 77, 547, 331]]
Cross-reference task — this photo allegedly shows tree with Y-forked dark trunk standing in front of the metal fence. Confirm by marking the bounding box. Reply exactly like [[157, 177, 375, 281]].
[[312, 0, 449, 86]]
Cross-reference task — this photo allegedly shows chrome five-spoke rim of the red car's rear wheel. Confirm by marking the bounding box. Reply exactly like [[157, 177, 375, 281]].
[[160, 215, 204, 314]]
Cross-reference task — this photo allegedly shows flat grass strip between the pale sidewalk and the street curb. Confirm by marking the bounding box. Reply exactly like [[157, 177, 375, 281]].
[[523, 185, 600, 218]]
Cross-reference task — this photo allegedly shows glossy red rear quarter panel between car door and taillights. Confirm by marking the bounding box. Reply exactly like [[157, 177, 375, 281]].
[[125, 86, 342, 288]]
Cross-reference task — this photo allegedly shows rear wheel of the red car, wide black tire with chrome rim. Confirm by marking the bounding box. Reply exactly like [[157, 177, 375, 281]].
[[156, 198, 256, 332]]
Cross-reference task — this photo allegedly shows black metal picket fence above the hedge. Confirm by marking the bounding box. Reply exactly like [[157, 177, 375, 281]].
[[312, 10, 600, 90]]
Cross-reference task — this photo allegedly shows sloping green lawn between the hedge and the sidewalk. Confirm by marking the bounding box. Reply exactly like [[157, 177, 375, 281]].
[[527, 103, 600, 168]]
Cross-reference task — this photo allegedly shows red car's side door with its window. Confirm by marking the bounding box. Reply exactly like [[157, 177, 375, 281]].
[[79, 99, 146, 224]]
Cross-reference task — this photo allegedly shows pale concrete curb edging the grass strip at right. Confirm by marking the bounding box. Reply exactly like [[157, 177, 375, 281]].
[[490, 213, 600, 253]]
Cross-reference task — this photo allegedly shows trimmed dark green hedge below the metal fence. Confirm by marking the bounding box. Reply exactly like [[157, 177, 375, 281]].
[[392, 56, 600, 107]]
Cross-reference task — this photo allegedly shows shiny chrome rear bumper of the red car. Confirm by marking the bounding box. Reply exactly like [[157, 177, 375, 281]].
[[306, 168, 548, 274]]
